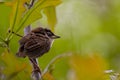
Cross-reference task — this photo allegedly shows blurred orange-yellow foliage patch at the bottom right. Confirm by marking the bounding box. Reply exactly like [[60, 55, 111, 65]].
[[70, 55, 107, 80]]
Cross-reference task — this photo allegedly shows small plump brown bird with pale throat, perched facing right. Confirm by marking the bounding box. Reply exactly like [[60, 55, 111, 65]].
[[15, 27, 60, 73]]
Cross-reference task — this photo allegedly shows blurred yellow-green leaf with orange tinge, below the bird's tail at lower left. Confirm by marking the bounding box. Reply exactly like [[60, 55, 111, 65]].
[[0, 52, 32, 79]]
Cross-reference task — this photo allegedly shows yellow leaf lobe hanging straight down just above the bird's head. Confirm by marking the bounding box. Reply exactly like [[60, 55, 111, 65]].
[[44, 6, 57, 31]]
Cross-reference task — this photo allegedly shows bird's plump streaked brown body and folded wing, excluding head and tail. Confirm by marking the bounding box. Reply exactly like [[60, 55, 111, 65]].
[[24, 35, 53, 58]]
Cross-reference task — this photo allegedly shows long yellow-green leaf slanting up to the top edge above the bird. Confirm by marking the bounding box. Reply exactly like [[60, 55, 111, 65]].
[[16, 0, 61, 32]]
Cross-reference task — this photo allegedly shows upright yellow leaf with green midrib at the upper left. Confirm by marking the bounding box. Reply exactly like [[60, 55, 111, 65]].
[[6, 0, 28, 30]]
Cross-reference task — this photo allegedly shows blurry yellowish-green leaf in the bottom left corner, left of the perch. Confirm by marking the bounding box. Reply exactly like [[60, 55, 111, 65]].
[[0, 51, 32, 80]]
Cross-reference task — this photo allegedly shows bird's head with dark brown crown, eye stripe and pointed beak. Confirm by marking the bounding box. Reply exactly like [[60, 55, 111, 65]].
[[32, 27, 60, 39]]
